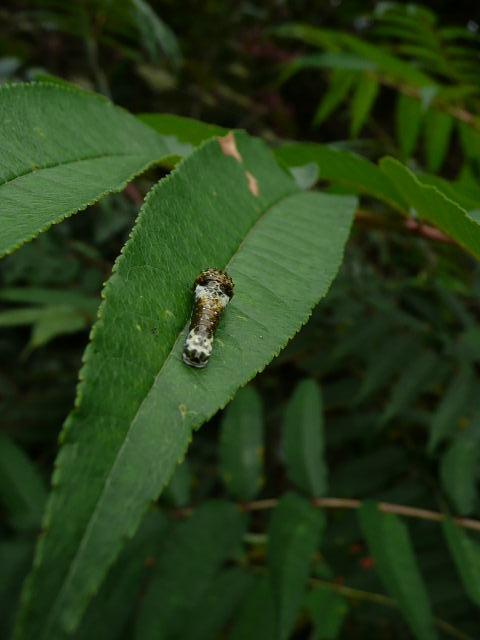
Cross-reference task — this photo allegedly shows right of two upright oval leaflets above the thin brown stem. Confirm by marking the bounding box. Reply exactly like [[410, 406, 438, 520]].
[[282, 380, 327, 497]]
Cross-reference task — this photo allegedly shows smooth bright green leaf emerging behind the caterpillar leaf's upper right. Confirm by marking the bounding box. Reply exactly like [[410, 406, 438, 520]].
[[275, 142, 406, 211]]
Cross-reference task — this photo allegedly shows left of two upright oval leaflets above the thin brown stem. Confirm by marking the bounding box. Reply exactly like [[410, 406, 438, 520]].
[[219, 386, 264, 500]]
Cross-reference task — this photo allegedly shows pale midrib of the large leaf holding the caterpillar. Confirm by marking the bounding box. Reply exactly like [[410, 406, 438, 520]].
[[39, 182, 301, 637]]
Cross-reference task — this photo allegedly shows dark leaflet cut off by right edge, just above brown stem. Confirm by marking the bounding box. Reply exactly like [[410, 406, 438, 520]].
[[440, 435, 479, 516]]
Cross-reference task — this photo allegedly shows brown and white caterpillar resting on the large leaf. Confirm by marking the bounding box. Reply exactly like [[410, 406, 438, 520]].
[[183, 269, 234, 369]]
